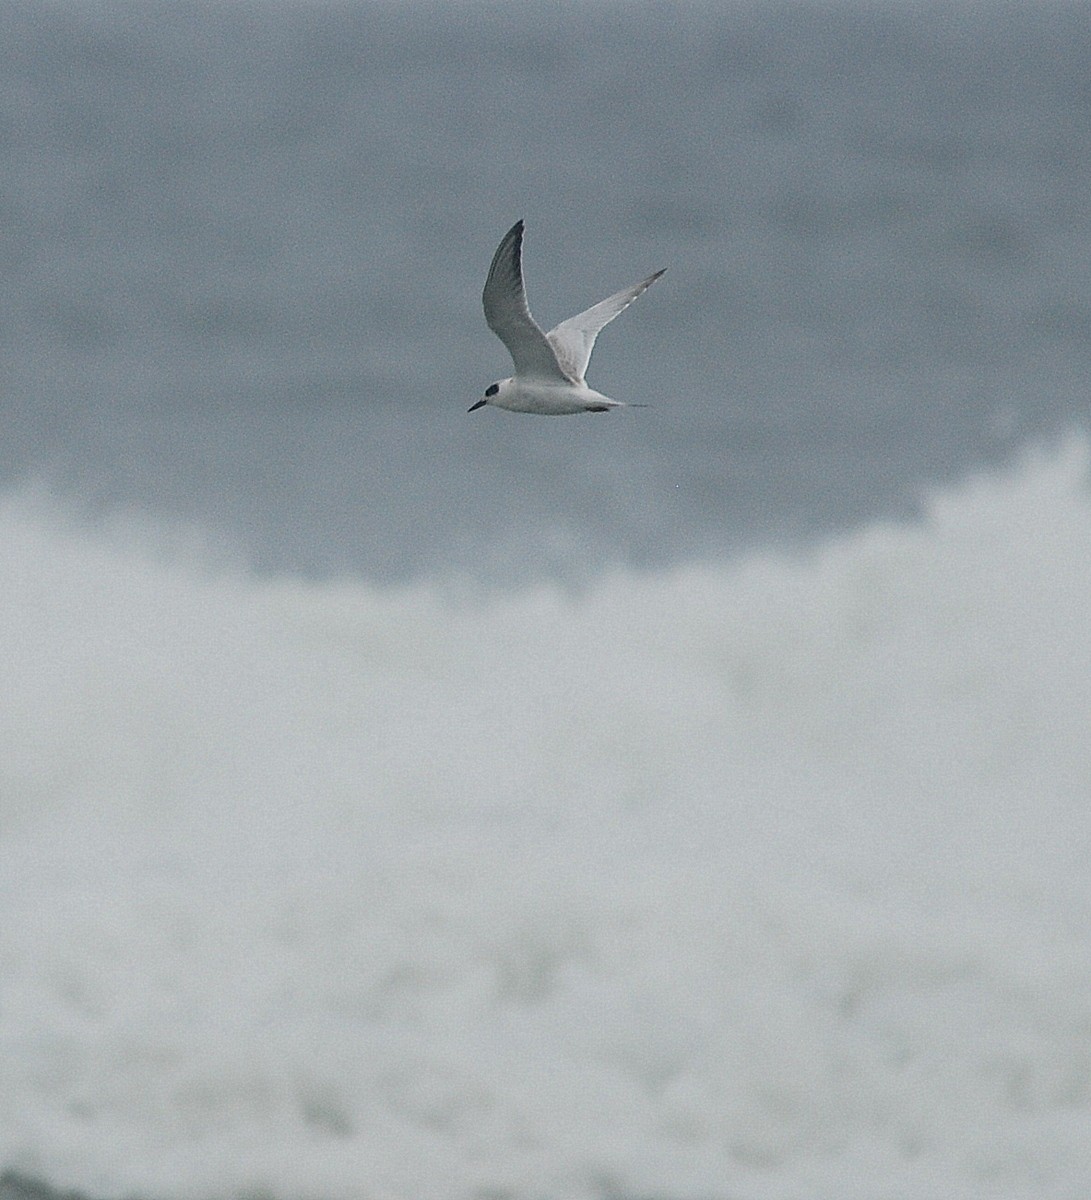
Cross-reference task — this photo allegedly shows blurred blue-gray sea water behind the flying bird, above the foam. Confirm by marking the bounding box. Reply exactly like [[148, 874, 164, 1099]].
[[0, 2, 1091, 581]]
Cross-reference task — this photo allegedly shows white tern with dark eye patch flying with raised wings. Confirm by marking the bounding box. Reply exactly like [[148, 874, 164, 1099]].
[[469, 221, 665, 416]]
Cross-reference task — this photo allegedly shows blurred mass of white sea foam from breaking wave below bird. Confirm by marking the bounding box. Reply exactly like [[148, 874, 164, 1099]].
[[0, 438, 1091, 1200]]
